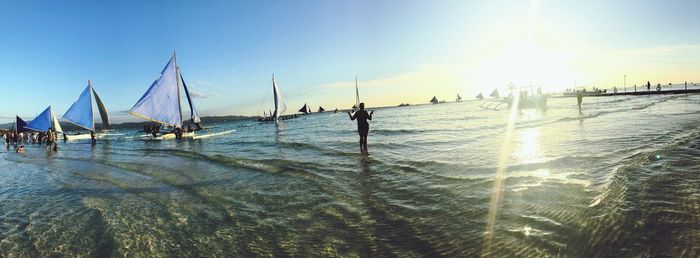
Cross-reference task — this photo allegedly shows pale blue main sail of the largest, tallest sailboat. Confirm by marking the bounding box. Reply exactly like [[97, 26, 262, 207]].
[[129, 55, 182, 127]]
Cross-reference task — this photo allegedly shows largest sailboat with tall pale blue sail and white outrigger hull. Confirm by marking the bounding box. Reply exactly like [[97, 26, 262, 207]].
[[129, 52, 235, 140]]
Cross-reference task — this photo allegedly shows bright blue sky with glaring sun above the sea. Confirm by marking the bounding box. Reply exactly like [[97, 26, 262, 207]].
[[0, 0, 700, 123]]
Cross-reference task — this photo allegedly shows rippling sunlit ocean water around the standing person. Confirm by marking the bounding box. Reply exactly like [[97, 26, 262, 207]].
[[0, 95, 700, 257]]
